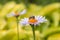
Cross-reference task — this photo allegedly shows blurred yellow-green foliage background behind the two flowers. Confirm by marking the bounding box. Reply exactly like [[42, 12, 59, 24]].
[[0, 0, 60, 40]]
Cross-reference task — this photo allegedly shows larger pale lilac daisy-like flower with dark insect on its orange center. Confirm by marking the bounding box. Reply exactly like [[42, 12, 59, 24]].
[[20, 16, 47, 25]]
